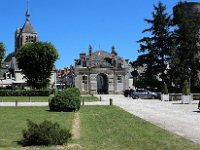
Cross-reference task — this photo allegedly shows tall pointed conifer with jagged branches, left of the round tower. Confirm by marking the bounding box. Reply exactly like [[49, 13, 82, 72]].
[[134, 2, 173, 84]]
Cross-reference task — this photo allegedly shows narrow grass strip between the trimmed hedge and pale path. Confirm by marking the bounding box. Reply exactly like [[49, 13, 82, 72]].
[[0, 95, 53, 102]]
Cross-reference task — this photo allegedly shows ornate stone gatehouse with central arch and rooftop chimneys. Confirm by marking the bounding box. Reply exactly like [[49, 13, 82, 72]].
[[74, 46, 129, 94]]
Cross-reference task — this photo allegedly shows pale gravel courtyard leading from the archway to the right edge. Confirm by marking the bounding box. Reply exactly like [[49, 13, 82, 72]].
[[95, 95, 200, 144]]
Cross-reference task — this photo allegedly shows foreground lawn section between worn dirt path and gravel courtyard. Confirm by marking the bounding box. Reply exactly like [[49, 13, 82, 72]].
[[78, 106, 200, 150]]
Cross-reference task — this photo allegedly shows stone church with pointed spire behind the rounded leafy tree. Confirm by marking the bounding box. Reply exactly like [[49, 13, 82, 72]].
[[0, 9, 56, 87]]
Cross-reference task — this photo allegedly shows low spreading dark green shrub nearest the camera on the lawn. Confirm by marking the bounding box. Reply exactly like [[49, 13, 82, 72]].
[[20, 120, 72, 146]]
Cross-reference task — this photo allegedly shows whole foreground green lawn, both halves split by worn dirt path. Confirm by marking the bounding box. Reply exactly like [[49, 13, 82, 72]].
[[0, 106, 200, 150]]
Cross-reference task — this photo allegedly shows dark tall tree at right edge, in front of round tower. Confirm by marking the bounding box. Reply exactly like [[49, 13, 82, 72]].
[[171, 2, 200, 90]]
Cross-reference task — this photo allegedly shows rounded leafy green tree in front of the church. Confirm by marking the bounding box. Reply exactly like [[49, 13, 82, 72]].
[[16, 42, 58, 89]]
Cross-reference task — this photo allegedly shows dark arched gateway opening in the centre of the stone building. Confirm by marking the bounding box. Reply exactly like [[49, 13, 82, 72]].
[[96, 73, 108, 94]]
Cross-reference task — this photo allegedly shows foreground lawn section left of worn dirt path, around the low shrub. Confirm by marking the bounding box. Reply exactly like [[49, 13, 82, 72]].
[[0, 107, 74, 149]]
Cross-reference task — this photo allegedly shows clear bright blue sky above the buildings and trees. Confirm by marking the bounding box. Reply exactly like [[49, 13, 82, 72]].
[[0, 0, 200, 69]]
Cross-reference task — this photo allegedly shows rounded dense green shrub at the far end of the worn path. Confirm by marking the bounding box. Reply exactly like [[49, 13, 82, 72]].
[[49, 88, 81, 112]]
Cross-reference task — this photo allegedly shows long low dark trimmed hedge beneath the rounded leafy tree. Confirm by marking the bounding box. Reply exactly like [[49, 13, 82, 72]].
[[0, 89, 50, 96]]
